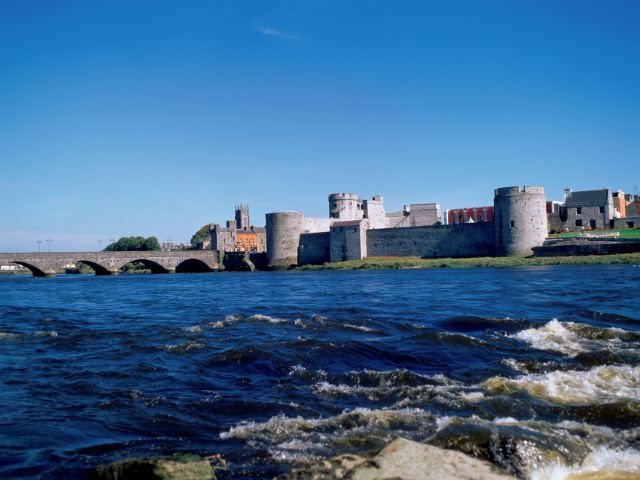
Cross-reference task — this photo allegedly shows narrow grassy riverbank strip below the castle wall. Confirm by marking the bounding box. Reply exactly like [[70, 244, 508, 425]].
[[297, 253, 640, 270]]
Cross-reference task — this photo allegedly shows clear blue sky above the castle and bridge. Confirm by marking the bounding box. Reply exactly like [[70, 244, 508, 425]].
[[0, 0, 640, 251]]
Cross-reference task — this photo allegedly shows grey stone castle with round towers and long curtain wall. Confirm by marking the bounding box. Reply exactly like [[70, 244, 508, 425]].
[[266, 186, 548, 267]]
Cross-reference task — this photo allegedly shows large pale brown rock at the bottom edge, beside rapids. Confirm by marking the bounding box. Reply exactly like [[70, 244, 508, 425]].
[[277, 438, 514, 480]]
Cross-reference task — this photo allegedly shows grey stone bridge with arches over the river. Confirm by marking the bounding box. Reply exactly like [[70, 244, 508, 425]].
[[0, 250, 219, 277]]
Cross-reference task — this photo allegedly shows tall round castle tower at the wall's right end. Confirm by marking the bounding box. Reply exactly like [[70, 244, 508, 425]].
[[493, 187, 548, 257]]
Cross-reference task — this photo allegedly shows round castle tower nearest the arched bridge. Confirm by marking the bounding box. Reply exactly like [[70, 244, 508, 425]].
[[266, 212, 304, 267]]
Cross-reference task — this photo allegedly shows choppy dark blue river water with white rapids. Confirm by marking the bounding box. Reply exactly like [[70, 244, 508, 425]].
[[0, 265, 640, 479]]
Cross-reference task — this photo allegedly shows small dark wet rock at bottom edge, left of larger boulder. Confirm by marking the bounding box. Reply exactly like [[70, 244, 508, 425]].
[[94, 455, 216, 480]]
